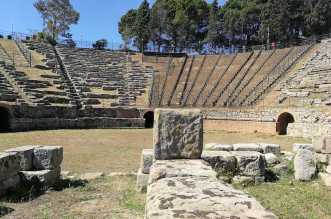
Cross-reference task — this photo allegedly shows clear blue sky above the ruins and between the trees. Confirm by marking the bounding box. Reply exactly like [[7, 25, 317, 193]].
[[0, 0, 224, 42]]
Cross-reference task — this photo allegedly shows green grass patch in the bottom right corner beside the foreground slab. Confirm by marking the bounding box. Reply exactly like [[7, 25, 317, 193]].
[[237, 177, 331, 219]]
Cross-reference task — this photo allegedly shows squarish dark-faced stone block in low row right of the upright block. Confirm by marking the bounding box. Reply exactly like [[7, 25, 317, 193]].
[[232, 151, 266, 176]]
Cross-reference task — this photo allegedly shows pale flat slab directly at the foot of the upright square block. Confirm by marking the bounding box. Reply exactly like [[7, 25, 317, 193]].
[[149, 160, 216, 184]]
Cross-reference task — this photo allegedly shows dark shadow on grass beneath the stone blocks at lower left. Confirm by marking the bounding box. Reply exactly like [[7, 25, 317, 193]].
[[2, 178, 88, 203]]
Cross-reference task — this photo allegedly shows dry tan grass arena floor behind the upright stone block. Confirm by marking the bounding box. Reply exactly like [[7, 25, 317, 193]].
[[0, 129, 309, 174]]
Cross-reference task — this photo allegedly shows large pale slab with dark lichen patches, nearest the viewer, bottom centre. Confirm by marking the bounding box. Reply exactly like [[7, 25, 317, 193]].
[[145, 177, 277, 219]]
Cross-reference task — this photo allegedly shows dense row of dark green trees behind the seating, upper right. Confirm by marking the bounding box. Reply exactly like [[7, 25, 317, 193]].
[[118, 0, 331, 51]]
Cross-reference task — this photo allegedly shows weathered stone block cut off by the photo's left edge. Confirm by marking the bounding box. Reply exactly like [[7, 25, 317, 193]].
[[0, 152, 21, 181]]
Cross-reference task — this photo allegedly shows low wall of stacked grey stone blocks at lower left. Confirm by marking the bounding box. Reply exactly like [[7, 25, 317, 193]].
[[0, 146, 63, 195]]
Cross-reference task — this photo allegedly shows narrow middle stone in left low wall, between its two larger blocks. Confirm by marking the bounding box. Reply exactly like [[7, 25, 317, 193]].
[[6, 146, 37, 171]]
